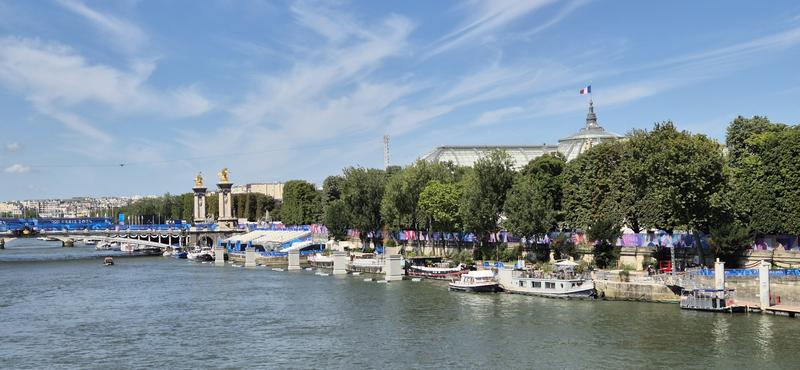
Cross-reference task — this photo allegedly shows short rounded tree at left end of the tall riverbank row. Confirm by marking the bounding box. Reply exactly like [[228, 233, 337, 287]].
[[281, 180, 319, 225]]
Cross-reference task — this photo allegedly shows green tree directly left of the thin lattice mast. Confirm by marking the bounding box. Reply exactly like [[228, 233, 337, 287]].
[[342, 167, 386, 249]]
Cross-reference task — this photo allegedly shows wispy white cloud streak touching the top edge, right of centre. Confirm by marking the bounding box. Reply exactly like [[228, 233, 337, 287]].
[[423, 0, 554, 59]]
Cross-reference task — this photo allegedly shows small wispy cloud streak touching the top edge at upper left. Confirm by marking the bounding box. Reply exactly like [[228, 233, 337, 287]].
[[57, 0, 147, 53]]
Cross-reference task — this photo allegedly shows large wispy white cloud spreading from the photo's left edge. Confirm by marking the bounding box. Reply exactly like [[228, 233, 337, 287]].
[[0, 37, 213, 141]]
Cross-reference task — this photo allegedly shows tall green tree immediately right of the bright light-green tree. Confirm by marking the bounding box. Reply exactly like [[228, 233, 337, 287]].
[[459, 150, 514, 244]]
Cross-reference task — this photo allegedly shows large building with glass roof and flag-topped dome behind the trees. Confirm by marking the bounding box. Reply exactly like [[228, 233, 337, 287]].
[[420, 101, 622, 169]]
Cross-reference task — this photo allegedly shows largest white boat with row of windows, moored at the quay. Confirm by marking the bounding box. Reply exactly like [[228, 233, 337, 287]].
[[497, 261, 597, 298]]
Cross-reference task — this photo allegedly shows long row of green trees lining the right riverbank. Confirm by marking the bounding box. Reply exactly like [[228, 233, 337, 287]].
[[282, 117, 800, 264]]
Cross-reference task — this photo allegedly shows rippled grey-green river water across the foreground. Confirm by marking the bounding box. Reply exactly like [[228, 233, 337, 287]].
[[0, 240, 800, 369]]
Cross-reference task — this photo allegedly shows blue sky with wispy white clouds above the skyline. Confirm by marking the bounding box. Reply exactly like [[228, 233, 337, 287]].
[[0, 0, 800, 200]]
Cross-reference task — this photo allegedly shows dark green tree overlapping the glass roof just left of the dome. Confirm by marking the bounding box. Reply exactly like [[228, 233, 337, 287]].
[[504, 154, 566, 246]]
